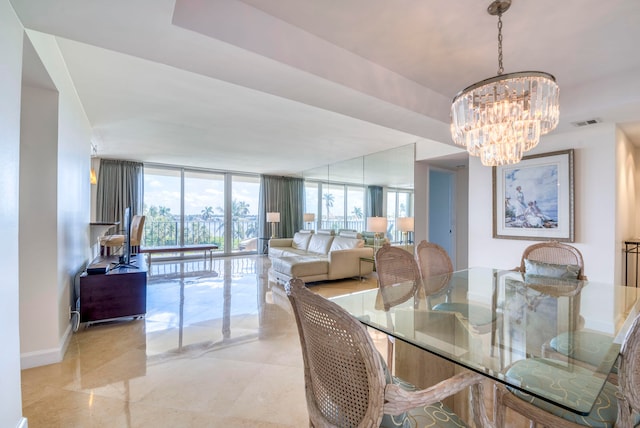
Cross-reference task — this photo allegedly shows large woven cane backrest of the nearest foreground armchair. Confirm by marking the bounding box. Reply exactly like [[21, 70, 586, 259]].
[[286, 278, 386, 427]]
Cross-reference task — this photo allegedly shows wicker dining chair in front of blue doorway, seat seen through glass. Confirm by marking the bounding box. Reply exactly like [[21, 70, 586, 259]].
[[416, 240, 496, 334]]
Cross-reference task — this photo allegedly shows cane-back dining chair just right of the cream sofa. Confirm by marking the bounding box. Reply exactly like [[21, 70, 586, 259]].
[[375, 243, 422, 373]]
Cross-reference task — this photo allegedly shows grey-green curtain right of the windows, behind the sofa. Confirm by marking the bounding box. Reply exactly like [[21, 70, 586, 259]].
[[259, 175, 304, 252]]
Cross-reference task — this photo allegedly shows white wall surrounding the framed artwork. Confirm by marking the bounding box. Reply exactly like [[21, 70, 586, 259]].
[[469, 124, 620, 283]]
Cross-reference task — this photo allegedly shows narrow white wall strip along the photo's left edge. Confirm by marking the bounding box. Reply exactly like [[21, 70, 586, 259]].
[[0, 0, 26, 427]]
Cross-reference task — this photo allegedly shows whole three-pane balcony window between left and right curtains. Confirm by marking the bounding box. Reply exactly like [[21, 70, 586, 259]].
[[144, 166, 260, 253]]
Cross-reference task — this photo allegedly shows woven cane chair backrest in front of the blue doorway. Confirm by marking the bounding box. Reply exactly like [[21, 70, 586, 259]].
[[416, 241, 453, 295]]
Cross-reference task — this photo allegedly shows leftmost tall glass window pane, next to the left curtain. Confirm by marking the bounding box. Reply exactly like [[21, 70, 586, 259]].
[[142, 166, 182, 247]]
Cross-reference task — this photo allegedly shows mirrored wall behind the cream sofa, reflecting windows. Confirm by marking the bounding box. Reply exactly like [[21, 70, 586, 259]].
[[302, 144, 415, 242]]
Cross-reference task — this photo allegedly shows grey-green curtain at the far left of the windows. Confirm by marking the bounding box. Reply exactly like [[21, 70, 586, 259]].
[[96, 159, 144, 224]]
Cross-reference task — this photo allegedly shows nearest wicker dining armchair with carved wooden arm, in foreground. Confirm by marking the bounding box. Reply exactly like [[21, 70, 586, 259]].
[[285, 278, 491, 428]]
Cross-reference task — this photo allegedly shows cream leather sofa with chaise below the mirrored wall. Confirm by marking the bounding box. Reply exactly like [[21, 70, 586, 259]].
[[269, 232, 373, 283]]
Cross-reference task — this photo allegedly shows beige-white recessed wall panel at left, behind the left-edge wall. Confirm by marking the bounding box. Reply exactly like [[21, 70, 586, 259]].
[[19, 83, 59, 358]]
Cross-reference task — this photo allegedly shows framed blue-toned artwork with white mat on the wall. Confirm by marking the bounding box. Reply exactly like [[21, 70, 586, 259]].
[[493, 149, 574, 242]]
